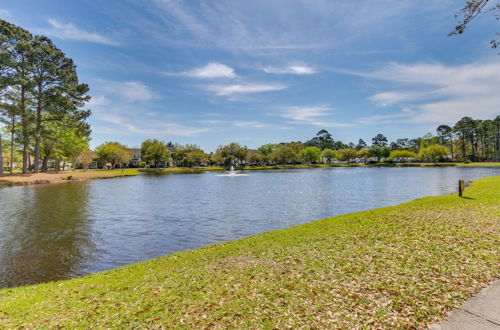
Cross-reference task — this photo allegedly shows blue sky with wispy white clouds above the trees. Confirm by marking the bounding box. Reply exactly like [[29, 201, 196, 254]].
[[0, 0, 500, 151]]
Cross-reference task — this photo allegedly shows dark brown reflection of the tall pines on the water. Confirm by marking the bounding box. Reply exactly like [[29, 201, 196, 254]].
[[0, 184, 95, 287]]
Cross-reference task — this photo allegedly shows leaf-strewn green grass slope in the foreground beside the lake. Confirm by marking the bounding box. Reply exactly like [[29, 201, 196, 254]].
[[0, 177, 500, 328]]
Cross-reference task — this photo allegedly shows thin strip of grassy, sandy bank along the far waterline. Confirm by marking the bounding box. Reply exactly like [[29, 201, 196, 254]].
[[0, 162, 500, 187]]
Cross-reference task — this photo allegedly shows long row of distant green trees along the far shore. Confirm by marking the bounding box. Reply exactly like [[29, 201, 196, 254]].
[[90, 116, 500, 168]]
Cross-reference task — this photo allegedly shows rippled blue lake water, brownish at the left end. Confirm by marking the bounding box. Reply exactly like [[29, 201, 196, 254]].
[[0, 167, 500, 287]]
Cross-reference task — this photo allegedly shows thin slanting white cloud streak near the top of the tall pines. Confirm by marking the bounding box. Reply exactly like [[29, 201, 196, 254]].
[[44, 18, 118, 46]]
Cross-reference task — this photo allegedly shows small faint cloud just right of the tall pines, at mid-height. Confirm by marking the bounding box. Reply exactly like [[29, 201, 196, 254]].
[[100, 80, 157, 103]]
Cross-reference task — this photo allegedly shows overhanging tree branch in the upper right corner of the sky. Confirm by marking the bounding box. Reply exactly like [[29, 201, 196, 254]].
[[449, 0, 500, 48]]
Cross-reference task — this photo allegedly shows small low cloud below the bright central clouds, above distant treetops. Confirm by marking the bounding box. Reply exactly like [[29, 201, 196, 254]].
[[281, 106, 351, 127]]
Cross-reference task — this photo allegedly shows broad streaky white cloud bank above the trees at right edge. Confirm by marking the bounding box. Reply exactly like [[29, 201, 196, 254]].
[[353, 62, 500, 124]]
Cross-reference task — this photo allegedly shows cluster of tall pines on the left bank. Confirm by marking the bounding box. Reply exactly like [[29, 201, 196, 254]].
[[0, 19, 91, 174]]
